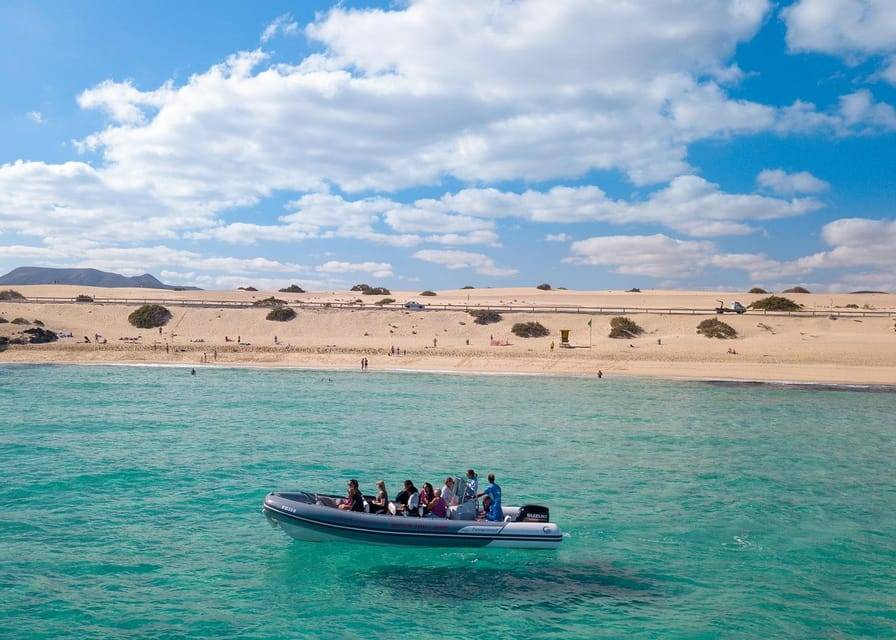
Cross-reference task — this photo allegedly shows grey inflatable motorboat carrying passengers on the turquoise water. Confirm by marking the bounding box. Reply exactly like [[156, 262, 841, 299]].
[[262, 491, 563, 549]]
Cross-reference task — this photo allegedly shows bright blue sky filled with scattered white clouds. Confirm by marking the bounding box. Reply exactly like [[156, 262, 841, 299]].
[[0, 0, 896, 290]]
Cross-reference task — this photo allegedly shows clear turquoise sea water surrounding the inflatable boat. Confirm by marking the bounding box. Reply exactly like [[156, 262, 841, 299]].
[[0, 366, 896, 639]]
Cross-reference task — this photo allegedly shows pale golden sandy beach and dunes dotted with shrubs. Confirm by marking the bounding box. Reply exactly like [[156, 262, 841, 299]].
[[0, 285, 896, 385]]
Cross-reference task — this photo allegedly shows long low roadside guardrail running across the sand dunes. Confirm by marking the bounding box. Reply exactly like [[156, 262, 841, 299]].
[[3, 296, 896, 318]]
